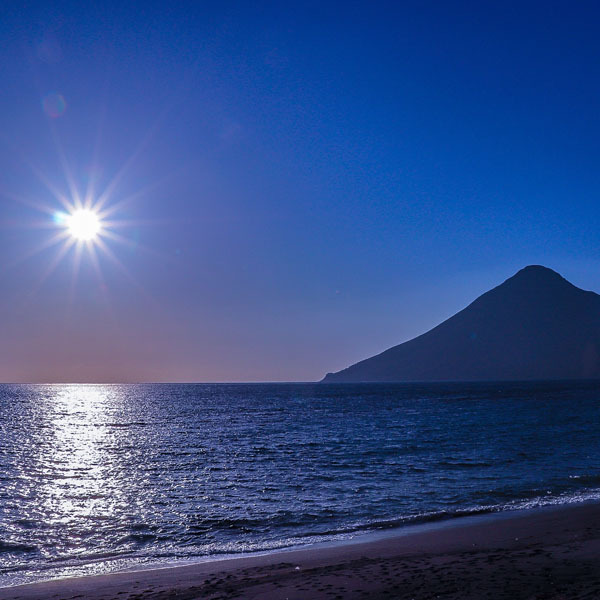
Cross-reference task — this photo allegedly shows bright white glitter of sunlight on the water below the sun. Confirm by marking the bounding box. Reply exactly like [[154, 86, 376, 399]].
[[30, 385, 137, 557]]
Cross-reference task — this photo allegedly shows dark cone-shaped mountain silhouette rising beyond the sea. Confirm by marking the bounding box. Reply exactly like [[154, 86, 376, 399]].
[[323, 265, 600, 383]]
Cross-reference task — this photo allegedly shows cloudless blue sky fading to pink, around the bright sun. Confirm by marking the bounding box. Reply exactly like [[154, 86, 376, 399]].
[[0, 1, 600, 382]]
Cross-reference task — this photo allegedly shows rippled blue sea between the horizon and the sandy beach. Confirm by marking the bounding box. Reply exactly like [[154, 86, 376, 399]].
[[0, 382, 600, 585]]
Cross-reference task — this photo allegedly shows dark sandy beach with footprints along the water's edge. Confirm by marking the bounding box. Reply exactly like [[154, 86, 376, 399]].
[[0, 504, 600, 600]]
